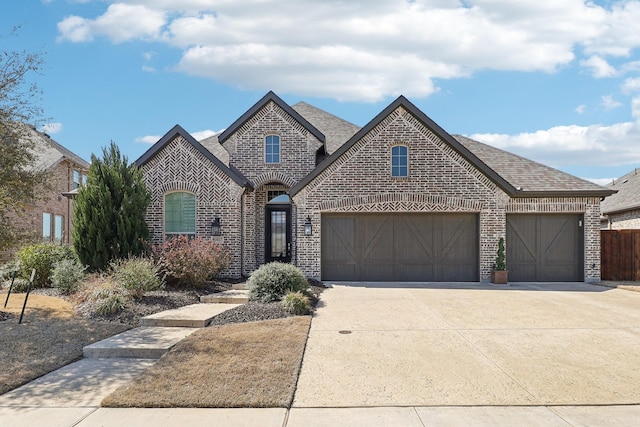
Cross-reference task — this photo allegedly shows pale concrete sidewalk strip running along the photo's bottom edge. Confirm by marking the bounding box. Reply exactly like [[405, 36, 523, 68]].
[[0, 406, 640, 427]]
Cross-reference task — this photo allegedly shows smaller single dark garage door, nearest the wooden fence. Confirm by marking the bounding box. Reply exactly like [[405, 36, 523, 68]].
[[506, 214, 584, 282]]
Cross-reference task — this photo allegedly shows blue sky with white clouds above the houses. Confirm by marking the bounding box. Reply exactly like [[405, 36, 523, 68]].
[[0, 0, 640, 183]]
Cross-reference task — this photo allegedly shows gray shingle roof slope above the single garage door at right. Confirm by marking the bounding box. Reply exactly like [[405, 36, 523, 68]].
[[453, 135, 607, 194]]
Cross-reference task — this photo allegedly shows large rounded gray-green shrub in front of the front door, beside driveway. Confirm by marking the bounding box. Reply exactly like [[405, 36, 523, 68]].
[[247, 262, 309, 302]]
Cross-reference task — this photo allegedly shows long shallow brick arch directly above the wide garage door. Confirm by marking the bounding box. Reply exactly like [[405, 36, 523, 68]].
[[319, 193, 483, 212]]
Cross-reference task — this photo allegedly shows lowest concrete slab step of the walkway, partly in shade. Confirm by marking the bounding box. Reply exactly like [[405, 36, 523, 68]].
[[82, 326, 198, 359]]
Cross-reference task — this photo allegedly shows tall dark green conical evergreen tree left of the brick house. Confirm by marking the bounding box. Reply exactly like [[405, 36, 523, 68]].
[[73, 142, 151, 270]]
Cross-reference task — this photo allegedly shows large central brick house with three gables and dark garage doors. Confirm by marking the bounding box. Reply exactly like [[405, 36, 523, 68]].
[[136, 92, 612, 282]]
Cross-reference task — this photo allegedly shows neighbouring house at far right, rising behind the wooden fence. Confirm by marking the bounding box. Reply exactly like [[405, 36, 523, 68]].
[[600, 169, 640, 230]]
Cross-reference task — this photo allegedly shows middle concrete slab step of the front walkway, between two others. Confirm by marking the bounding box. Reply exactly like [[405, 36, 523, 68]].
[[140, 303, 240, 328]]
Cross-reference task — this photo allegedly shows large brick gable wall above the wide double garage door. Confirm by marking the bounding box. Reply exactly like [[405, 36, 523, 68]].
[[291, 105, 499, 207]]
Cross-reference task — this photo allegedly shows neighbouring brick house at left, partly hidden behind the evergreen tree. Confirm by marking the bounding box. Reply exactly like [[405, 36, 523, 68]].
[[0, 127, 89, 258]]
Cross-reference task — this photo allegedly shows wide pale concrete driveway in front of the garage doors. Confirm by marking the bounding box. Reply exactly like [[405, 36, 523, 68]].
[[293, 283, 640, 408]]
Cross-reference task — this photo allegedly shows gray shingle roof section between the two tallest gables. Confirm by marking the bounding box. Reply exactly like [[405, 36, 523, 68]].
[[291, 102, 360, 154]]
